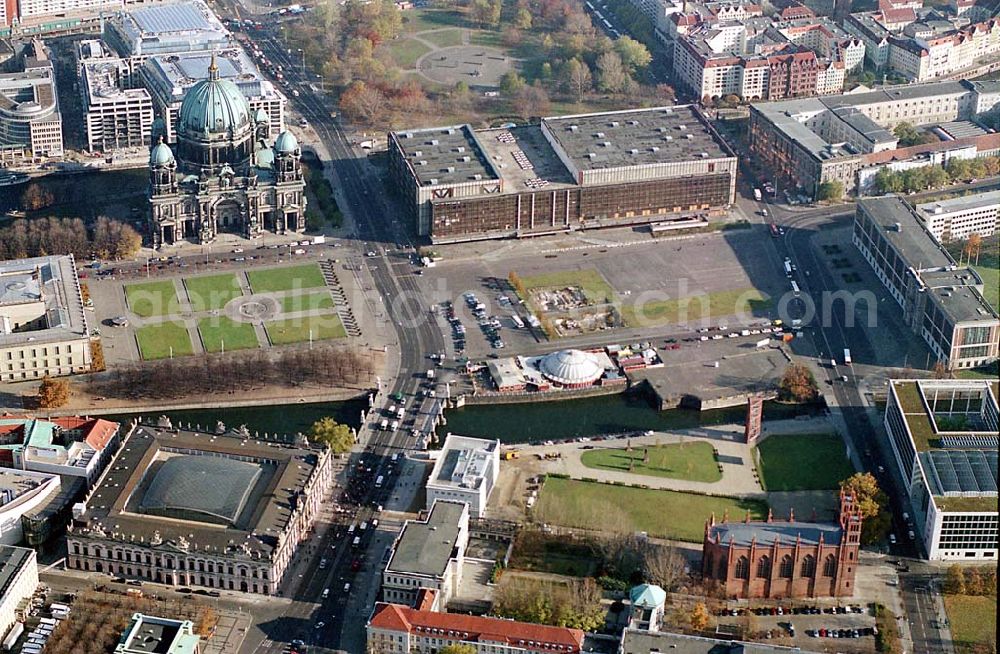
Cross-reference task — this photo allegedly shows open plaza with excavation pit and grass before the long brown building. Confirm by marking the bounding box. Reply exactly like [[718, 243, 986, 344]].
[[419, 225, 789, 357]]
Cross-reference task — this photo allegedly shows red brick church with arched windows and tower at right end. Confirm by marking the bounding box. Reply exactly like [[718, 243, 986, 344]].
[[701, 492, 861, 599]]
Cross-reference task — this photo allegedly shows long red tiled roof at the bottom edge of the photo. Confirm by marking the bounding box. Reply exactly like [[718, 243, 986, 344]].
[[369, 602, 583, 654]]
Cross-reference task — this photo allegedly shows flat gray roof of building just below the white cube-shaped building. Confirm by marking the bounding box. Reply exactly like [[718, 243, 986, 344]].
[[385, 500, 467, 577]]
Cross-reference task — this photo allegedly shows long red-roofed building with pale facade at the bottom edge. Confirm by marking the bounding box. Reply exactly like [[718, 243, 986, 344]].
[[367, 602, 584, 654]]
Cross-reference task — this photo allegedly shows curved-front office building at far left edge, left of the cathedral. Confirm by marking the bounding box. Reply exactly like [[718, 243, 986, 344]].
[[0, 41, 63, 166]]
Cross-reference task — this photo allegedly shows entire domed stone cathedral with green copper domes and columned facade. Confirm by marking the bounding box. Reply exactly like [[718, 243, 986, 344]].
[[149, 53, 306, 247]]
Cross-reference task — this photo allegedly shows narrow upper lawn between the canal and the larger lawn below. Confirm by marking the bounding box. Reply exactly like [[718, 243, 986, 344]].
[[580, 441, 722, 482]]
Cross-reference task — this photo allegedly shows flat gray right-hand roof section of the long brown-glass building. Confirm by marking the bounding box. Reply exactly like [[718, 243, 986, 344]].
[[542, 105, 731, 170]]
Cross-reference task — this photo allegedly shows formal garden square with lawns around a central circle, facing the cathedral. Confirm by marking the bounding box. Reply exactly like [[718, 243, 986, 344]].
[[88, 261, 364, 365]]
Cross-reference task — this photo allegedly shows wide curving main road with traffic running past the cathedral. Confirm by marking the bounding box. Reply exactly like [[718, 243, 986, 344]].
[[238, 11, 444, 654]]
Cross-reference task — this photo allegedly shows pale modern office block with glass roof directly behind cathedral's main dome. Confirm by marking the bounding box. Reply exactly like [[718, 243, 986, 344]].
[[138, 46, 287, 144]]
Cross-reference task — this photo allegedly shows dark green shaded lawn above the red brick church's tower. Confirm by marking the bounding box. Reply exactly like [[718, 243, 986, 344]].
[[757, 434, 854, 491]]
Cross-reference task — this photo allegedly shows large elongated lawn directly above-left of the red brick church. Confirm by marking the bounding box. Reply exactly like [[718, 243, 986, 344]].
[[536, 477, 767, 543]]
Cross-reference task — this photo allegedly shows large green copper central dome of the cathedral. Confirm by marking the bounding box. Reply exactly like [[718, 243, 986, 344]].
[[177, 56, 251, 135]]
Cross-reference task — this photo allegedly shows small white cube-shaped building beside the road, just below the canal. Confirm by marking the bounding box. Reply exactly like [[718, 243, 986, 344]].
[[426, 434, 500, 518]]
